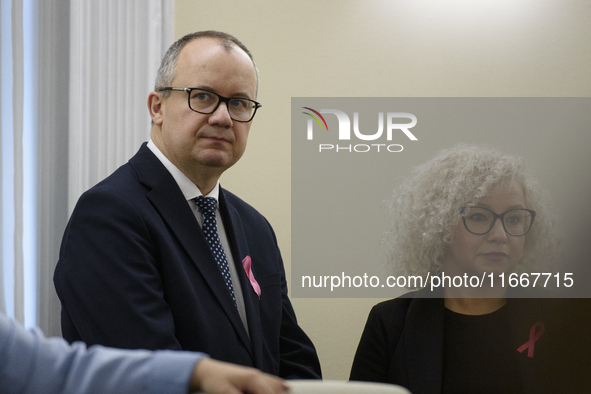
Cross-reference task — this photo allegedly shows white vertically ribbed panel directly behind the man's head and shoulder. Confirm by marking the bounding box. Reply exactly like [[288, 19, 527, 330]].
[[68, 0, 174, 211]]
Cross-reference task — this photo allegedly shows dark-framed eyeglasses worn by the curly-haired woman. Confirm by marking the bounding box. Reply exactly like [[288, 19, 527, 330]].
[[460, 207, 536, 237]]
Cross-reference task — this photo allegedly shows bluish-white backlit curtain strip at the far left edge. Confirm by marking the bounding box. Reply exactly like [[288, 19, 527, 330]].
[[0, 0, 40, 326]]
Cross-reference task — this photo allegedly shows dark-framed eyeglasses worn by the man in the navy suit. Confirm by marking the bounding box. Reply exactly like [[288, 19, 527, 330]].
[[158, 87, 262, 123]]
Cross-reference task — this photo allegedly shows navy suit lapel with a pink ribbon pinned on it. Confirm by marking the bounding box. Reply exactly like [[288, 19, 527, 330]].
[[220, 188, 263, 366]]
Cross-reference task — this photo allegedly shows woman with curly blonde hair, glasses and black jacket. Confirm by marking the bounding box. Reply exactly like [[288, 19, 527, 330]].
[[351, 145, 580, 394]]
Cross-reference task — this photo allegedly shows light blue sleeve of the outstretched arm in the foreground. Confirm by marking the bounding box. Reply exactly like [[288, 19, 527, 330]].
[[0, 314, 207, 394]]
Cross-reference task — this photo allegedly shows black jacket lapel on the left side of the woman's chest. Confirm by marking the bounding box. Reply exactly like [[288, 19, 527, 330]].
[[404, 298, 444, 394]]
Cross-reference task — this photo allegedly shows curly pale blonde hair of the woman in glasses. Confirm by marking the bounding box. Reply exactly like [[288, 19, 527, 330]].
[[383, 144, 556, 284]]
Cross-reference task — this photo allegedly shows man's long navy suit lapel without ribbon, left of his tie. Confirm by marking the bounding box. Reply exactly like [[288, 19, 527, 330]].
[[129, 144, 251, 349]]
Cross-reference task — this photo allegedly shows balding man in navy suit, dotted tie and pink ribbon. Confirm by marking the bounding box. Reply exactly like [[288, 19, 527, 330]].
[[54, 31, 320, 378]]
